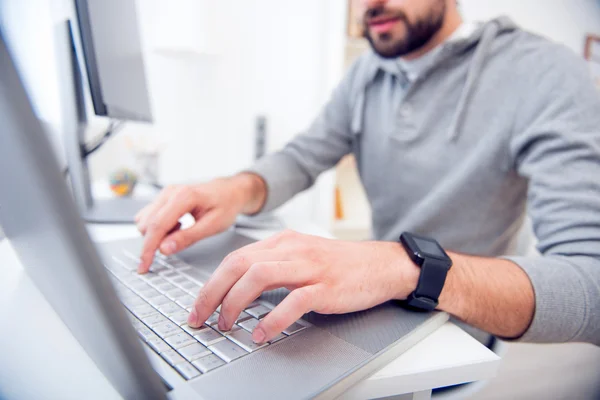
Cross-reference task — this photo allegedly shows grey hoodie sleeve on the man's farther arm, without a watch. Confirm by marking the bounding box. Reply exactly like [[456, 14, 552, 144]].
[[247, 60, 360, 212]]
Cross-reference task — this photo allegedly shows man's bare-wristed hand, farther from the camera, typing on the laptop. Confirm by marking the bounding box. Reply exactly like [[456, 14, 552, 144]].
[[135, 173, 267, 273]]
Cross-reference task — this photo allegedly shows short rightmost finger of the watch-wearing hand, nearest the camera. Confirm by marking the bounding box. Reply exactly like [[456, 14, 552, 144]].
[[252, 286, 321, 343]]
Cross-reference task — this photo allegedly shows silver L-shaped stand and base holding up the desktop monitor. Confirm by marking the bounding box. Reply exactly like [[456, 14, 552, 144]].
[[56, 21, 151, 223]]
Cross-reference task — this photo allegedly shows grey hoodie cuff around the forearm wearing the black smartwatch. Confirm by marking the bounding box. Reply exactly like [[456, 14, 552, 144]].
[[503, 257, 588, 343]]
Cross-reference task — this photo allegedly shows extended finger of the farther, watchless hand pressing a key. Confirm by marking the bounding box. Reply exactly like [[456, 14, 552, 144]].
[[138, 196, 192, 274]]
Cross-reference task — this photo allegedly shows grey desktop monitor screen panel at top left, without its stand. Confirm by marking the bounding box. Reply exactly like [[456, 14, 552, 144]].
[[75, 0, 152, 122]]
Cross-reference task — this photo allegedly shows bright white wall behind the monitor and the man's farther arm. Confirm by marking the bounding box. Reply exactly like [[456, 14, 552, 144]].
[[0, 0, 346, 228]]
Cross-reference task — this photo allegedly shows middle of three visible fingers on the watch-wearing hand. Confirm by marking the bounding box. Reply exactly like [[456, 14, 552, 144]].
[[219, 261, 312, 330]]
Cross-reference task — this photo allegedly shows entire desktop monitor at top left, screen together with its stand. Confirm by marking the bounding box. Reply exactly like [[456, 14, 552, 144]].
[[57, 0, 152, 223]]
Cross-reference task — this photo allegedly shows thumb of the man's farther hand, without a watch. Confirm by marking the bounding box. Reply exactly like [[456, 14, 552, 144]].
[[160, 211, 227, 255]]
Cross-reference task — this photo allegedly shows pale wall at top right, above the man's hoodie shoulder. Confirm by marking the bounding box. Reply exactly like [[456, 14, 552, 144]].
[[459, 0, 600, 56]]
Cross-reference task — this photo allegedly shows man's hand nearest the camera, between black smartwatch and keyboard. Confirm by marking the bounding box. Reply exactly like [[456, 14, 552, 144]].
[[188, 231, 419, 343]]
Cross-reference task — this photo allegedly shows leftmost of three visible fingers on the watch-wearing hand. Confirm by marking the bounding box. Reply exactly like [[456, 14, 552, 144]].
[[188, 251, 285, 327]]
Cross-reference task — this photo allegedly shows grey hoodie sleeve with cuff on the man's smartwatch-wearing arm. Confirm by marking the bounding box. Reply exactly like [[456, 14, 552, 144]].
[[509, 45, 600, 345]]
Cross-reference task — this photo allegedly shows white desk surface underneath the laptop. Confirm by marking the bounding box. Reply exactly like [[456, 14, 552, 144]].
[[0, 221, 500, 400]]
